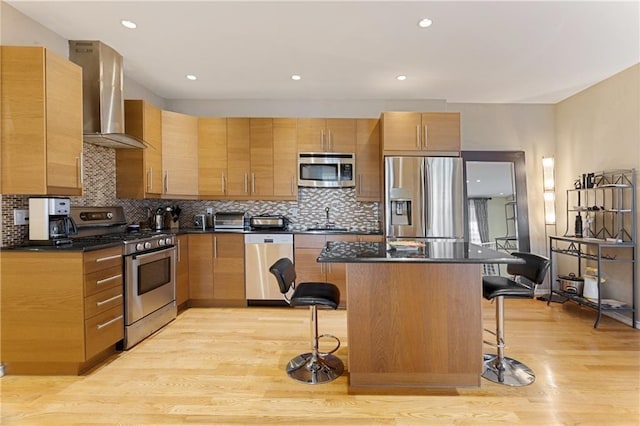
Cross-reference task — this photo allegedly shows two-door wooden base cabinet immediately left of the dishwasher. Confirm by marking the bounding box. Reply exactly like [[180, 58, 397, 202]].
[[188, 233, 247, 306]]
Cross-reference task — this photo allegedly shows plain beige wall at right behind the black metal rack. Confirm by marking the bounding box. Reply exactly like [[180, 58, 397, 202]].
[[555, 64, 640, 320]]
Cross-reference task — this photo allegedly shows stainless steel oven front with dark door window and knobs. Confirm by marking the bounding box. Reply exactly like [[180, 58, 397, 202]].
[[124, 235, 177, 349]]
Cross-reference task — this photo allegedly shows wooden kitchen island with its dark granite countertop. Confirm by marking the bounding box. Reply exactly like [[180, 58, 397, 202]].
[[317, 241, 521, 393]]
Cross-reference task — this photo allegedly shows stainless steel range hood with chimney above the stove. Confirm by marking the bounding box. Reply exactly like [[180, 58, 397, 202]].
[[69, 40, 146, 148]]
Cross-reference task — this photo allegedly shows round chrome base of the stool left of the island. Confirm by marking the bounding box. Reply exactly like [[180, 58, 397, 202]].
[[287, 352, 344, 385]]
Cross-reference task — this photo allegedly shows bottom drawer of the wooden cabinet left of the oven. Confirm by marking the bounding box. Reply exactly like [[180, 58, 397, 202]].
[[84, 303, 124, 360]]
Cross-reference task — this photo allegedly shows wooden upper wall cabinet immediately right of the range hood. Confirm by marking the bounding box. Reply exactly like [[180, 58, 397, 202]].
[[116, 99, 162, 198]]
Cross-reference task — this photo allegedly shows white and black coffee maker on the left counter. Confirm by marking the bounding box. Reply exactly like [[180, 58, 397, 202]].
[[29, 197, 78, 245]]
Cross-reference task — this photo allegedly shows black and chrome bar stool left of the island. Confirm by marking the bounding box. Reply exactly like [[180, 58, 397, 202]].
[[269, 257, 344, 385]]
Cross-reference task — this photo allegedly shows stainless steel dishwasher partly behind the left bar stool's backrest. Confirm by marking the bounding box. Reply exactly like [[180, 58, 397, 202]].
[[244, 234, 293, 305]]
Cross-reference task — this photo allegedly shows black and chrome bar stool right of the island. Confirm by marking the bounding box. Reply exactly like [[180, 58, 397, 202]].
[[482, 252, 550, 386]]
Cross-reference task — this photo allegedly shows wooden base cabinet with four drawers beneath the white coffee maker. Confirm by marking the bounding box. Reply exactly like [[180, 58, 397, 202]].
[[0, 247, 124, 374]]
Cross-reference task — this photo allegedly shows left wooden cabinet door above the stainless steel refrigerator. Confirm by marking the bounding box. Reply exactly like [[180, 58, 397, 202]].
[[381, 112, 422, 151]]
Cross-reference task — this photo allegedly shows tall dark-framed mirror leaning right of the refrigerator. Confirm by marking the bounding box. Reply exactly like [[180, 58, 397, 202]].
[[462, 151, 530, 262]]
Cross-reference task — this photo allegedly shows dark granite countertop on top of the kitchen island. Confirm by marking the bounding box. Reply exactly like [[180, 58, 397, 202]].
[[317, 240, 522, 263]]
